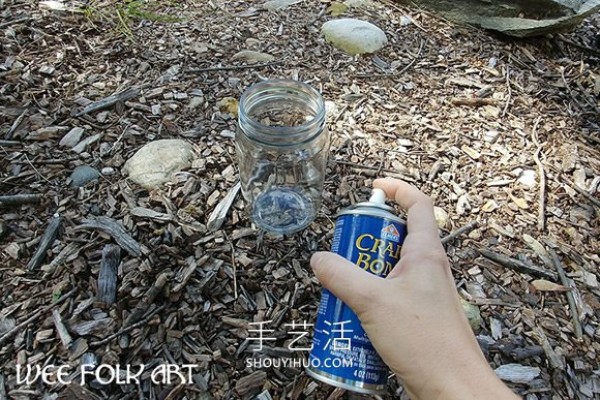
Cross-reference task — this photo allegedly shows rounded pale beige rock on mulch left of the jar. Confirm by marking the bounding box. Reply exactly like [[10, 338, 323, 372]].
[[123, 139, 194, 189]]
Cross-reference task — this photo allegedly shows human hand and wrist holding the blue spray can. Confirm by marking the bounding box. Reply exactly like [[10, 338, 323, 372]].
[[311, 178, 516, 400]]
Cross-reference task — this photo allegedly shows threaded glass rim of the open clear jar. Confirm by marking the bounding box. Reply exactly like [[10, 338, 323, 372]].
[[238, 79, 326, 146]]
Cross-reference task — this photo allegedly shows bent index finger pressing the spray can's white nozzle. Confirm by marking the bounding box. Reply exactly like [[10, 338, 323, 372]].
[[373, 178, 440, 238]]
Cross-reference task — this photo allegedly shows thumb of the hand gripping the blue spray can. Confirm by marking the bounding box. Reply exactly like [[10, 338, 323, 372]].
[[310, 251, 385, 314]]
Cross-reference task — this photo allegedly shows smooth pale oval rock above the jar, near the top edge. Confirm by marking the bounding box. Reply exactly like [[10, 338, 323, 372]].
[[321, 18, 387, 55]]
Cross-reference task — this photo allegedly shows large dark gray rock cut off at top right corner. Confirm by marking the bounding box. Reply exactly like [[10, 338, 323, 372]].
[[415, 0, 600, 37]]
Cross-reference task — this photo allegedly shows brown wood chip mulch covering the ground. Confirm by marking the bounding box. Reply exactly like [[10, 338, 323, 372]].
[[0, 0, 600, 400]]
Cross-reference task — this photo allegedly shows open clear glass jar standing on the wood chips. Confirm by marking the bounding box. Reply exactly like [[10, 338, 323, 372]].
[[235, 80, 329, 234]]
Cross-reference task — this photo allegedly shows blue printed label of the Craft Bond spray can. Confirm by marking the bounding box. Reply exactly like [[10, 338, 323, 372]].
[[309, 214, 406, 392]]
